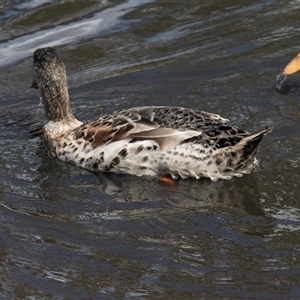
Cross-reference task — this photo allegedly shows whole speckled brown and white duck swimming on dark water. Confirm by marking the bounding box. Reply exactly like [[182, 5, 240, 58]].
[[31, 47, 272, 181]]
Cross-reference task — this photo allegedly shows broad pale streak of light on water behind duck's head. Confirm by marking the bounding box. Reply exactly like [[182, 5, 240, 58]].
[[0, 0, 151, 66]]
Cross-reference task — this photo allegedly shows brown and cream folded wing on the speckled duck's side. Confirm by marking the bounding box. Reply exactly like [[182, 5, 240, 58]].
[[73, 113, 201, 150]]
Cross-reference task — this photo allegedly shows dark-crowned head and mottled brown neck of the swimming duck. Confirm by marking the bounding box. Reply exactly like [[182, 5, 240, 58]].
[[31, 47, 74, 122]]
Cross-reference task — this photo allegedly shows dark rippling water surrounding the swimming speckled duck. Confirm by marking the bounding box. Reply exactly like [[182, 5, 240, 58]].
[[0, 0, 300, 300]]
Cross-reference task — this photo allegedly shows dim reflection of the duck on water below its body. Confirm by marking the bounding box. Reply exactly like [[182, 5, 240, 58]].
[[93, 173, 264, 216]]
